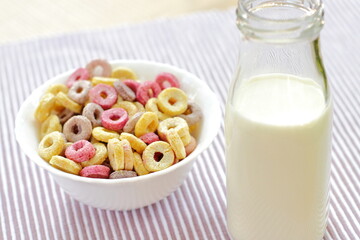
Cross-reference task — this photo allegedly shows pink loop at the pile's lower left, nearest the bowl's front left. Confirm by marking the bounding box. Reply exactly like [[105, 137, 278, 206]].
[[65, 140, 96, 163]]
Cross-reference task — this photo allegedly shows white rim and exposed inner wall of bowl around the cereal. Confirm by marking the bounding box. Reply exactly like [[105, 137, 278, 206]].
[[15, 60, 221, 184]]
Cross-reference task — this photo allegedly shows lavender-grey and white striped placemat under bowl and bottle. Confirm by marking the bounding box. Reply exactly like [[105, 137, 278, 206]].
[[0, 0, 360, 240]]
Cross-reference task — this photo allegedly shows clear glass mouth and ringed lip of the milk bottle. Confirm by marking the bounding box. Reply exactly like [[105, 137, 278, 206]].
[[237, 0, 324, 43]]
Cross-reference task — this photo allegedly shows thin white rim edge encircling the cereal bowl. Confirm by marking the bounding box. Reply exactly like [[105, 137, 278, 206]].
[[15, 59, 222, 185]]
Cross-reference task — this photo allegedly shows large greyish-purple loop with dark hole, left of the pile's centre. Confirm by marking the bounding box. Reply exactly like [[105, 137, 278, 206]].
[[63, 115, 92, 142]]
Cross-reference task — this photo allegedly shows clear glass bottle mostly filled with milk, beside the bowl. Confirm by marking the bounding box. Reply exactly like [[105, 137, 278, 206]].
[[225, 0, 332, 240]]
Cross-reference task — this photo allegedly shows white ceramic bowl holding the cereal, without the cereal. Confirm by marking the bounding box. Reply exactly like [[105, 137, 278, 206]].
[[15, 60, 221, 210]]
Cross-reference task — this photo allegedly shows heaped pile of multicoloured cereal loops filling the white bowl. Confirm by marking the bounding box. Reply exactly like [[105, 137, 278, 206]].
[[35, 59, 201, 179]]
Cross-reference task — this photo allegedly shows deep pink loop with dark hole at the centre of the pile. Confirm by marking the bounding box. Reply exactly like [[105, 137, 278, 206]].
[[101, 108, 129, 131]]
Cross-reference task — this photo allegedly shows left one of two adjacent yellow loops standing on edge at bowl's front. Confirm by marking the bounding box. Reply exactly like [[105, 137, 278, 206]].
[[107, 138, 125, 171]]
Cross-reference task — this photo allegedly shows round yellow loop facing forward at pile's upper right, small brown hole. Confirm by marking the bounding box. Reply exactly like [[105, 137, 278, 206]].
[[158, 88, 188, 116]]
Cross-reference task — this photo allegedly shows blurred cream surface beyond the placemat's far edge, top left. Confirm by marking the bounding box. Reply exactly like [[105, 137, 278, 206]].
[[0, 0, 237, 44]]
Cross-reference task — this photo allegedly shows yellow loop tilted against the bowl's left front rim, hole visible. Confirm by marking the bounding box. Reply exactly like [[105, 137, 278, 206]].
[[38, 132, 65, 161]]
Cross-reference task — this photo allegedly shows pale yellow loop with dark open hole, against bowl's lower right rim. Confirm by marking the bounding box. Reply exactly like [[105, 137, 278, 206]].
[[142, 141, 175, 172]]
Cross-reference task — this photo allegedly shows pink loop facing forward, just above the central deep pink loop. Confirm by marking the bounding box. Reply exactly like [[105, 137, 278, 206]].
[[89, 83, 118, 109]]
